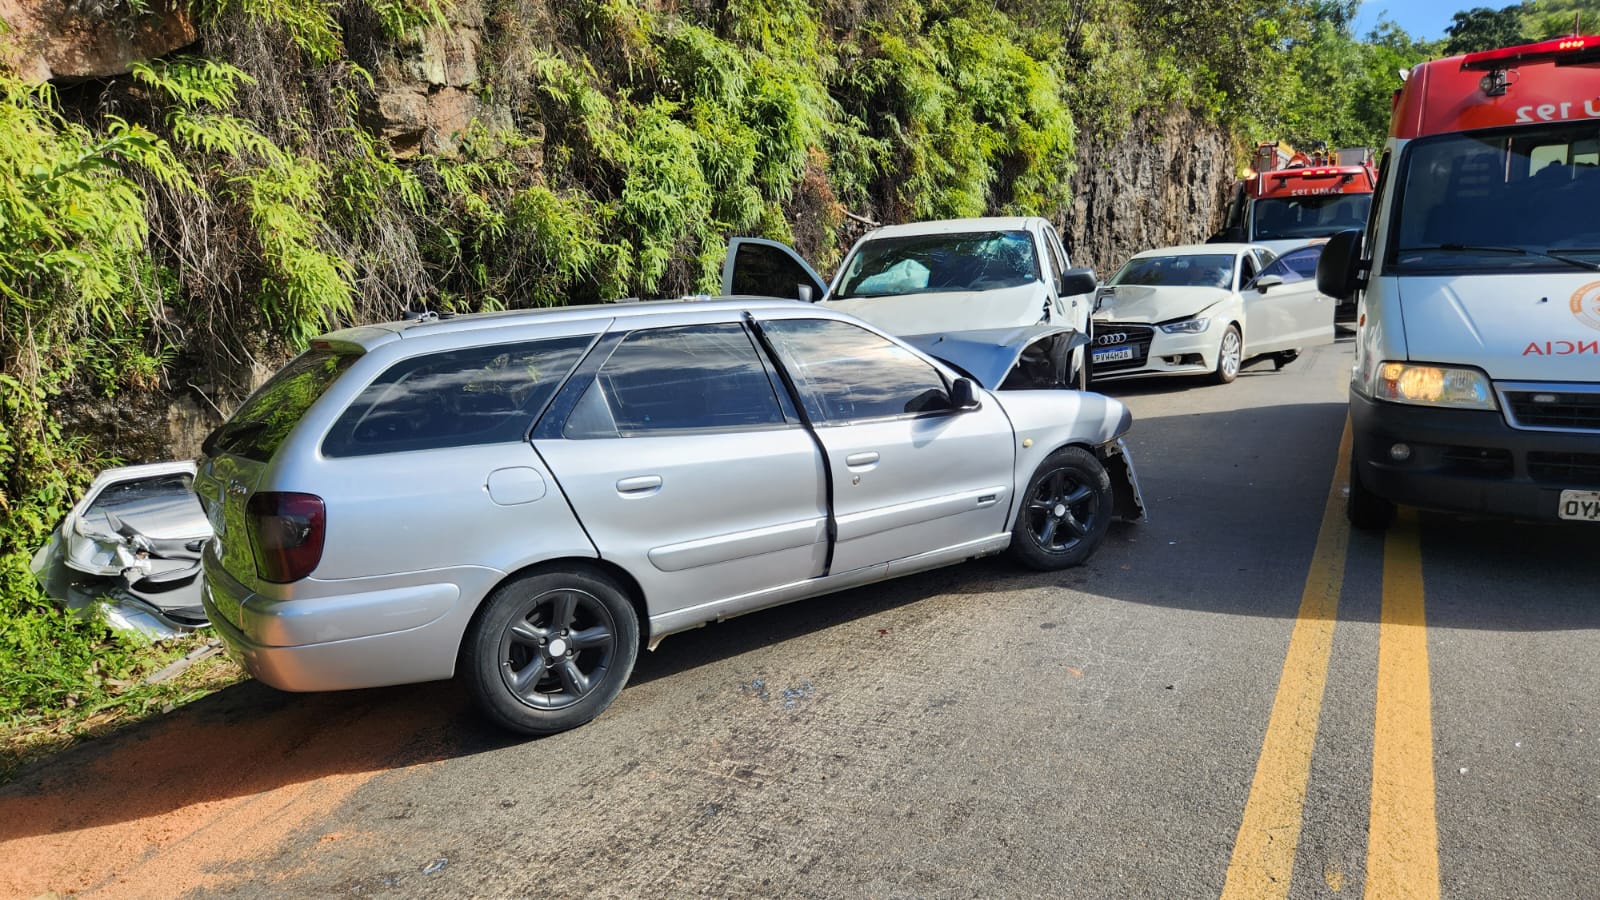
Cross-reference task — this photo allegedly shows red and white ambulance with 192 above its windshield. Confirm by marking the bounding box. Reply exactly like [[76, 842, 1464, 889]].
[[1317, 37, 1600, 528]]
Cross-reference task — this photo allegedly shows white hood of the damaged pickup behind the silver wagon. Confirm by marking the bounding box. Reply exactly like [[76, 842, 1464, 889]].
[[822, 282, 1048, 335]]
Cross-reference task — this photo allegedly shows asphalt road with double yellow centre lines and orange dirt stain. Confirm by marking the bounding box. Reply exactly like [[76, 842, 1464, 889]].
[[0, 333, 1600, 898]]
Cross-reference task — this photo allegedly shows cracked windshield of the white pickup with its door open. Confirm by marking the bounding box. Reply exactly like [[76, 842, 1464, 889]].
[[835, 231, 1040, 299]]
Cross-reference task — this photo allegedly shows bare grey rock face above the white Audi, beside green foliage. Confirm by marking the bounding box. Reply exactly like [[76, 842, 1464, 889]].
[[1062, 109, 1234, 279]]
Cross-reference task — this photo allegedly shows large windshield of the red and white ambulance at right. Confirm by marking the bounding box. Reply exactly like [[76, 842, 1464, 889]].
[[1387, 122, 1600, 272]]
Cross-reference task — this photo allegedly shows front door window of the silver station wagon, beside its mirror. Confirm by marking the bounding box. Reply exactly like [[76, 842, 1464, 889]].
[[762, 319, 950, 424]]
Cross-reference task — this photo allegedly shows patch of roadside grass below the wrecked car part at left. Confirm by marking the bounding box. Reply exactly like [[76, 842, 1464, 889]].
[[0, 621, 245, 785]]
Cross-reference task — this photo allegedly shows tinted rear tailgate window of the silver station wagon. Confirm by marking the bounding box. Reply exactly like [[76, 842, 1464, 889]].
[[200, 341, 362, 463]]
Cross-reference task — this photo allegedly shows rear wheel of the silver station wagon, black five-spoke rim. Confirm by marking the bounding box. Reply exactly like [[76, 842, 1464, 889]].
[[461, 569, 638, 735]]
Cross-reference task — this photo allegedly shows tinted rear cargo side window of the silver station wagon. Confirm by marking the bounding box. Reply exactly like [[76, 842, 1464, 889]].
[[322, 335, 594, 456]]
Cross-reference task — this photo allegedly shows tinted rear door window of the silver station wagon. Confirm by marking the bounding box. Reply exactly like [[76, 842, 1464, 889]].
[[562, 322, 789, 439]]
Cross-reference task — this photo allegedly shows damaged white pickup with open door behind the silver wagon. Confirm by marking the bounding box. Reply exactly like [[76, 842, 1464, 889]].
[[722, 216, 1096, 389]]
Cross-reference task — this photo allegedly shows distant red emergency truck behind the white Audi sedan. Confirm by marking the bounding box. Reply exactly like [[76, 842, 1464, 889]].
[[1211, 143, 1378, 253]]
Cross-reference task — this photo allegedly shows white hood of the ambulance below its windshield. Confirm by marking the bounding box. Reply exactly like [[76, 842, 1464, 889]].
[[1386, 271, 1600, 381]]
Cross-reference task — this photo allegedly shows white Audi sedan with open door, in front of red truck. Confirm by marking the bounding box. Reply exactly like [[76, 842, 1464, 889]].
[[1091, 243, 1334, 384]]
